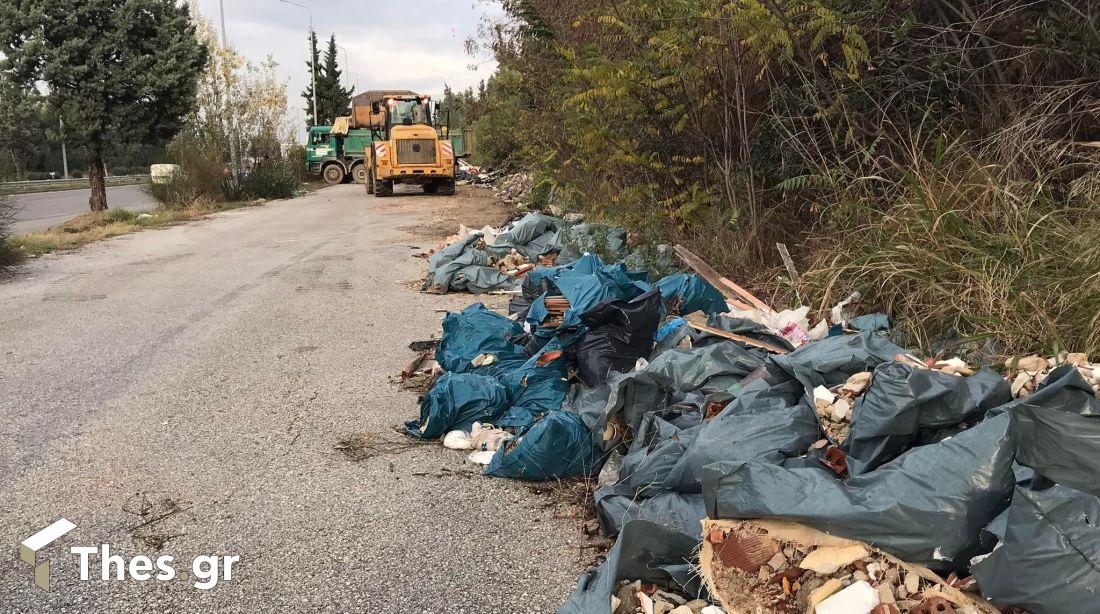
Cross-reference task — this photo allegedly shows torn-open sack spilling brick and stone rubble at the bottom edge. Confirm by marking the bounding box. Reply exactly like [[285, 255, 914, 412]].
[[699, 519, 999, 614]]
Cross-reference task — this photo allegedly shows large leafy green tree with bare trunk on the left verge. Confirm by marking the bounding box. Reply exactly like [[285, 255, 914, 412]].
[[0, 0, 207, 211]]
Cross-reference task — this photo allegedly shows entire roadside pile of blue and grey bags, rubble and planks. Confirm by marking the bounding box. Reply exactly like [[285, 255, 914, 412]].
[[406, 227, 1100, 614]]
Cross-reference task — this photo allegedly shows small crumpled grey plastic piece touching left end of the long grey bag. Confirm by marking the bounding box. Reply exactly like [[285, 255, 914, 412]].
[[594, 486, 706, 537]]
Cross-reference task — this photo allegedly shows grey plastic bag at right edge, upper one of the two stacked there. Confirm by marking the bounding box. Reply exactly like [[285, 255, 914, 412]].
[[1008, 365, 1100, 495]]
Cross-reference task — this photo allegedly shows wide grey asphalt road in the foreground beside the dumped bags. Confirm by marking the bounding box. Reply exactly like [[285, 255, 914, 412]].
[[0, 186, 586, 614]]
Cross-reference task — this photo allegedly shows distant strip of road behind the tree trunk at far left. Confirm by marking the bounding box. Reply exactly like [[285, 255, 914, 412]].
[[12, 186, 155, 232]]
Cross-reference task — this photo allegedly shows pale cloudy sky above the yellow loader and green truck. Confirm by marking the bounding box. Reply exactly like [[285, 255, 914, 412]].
[[193, 0, 501, 136]]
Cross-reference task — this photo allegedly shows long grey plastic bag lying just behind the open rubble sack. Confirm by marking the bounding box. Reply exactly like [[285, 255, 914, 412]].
[[700, 411, 1015, 571]]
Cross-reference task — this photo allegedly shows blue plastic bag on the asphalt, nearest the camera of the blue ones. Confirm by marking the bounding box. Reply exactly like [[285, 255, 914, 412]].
[[485, 409, 600, 482]]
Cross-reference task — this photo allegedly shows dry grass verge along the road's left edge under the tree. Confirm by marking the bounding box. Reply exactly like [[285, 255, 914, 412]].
[[7, 201, 257, 257]]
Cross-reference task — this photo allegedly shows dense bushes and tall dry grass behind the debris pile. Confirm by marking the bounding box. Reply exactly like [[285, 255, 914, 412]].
[[449, 0, 1100, 354]]
